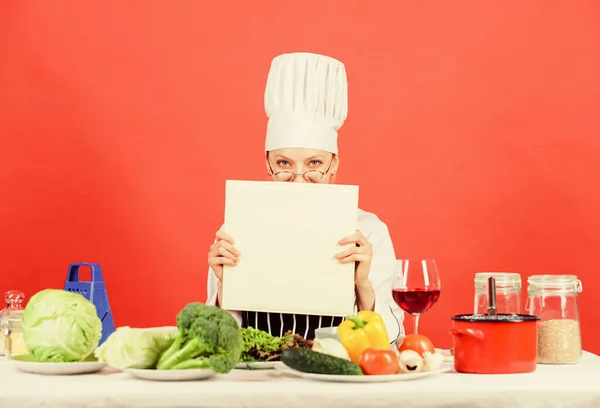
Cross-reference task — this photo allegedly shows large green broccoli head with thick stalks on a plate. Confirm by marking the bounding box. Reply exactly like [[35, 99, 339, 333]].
[[156, 302, 243, 373]]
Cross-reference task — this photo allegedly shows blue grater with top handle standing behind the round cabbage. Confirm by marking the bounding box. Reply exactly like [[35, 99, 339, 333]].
[[64, 263, 115, 345]]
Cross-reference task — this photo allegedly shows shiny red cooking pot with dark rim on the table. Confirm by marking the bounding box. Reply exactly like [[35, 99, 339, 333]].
[[450, 314, 540, 374]]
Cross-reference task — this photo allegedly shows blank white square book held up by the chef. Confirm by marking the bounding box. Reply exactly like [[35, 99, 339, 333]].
[[221, 180, 358, 316]]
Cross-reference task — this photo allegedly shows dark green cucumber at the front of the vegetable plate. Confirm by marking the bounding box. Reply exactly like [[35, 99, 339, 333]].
[[281, 348, 363, 375]]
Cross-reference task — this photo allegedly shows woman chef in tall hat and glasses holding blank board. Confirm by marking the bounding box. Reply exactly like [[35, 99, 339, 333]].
[[207, 53, 404, 344]]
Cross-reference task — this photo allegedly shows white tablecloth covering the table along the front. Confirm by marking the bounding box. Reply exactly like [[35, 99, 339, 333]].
[[0, 353, 600, 408]]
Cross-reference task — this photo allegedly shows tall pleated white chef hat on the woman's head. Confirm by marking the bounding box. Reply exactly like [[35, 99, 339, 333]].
[[265, 53, 348, 154]]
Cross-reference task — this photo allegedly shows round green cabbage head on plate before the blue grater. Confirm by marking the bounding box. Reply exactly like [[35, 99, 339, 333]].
[[23, 289, 102, 363]]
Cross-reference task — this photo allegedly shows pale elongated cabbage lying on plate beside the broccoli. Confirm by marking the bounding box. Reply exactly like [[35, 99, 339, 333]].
[[94, 326, 179, 370]]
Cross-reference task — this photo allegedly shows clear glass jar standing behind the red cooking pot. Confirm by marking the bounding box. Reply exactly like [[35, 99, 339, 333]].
[[473, 272, 521, 314]]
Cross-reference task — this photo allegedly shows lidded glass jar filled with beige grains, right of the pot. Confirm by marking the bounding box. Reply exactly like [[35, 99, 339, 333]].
[[526, 275, 583, 364]]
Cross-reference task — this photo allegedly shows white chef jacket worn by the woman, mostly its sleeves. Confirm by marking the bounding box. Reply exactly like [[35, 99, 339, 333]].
[[206, 209, 404, 344]]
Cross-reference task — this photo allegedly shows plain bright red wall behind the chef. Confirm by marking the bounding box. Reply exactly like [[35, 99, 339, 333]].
[[0, 0, 600, 352]]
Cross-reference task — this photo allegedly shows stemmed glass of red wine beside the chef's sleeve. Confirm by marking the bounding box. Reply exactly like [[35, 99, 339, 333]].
[[392, 259, 441, 334]]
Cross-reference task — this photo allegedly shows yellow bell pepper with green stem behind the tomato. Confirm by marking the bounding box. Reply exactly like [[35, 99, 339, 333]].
[[338, 310, 390, 364]]
